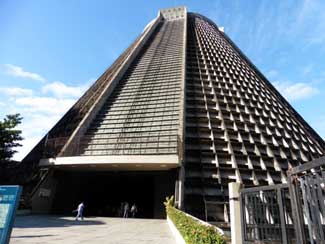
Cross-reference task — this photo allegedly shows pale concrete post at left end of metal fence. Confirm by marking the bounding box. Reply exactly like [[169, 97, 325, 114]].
[[228, 182, 243, 244]]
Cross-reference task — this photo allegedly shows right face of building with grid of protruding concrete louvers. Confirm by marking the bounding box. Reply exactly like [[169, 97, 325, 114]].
[[184, 13, 325, 222]]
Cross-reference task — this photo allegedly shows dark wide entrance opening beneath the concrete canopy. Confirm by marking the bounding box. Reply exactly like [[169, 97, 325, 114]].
[[52, 170, 176, 218]]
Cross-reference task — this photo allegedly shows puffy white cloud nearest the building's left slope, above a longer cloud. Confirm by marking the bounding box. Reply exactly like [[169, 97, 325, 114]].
[[42, 81, 87, 97]]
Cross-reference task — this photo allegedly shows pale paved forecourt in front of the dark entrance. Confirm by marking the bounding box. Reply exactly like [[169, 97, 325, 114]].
[[10, 215, 176, 244]]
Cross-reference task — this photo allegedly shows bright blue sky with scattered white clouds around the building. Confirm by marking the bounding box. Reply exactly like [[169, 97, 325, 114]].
[[0, 0, 325, 159]]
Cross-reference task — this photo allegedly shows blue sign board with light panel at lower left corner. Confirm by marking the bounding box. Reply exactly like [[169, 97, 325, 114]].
[[0, 186, 21, 244]]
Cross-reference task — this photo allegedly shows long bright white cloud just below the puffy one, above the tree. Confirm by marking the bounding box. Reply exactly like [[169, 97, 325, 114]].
[[15, 96, 75, 114]]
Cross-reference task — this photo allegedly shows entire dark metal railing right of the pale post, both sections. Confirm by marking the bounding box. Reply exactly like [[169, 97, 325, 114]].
[[240, 157, 325, 244]]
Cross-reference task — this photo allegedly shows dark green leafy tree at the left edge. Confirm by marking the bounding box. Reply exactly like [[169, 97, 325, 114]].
[[0, 114, 23, 162]]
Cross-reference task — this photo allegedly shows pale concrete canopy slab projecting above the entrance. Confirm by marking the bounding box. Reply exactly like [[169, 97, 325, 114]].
[[39, 155, 180, 170]]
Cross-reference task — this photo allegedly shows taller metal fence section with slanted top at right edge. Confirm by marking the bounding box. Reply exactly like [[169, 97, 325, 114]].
[[288, 157, 325, 244]]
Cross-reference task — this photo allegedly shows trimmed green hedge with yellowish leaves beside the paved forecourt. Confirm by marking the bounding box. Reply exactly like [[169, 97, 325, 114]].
[[164, 197, 226, 244]]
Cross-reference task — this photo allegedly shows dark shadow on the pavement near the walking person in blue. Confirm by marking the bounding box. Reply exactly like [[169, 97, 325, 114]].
[[14, 215, 105, 228]]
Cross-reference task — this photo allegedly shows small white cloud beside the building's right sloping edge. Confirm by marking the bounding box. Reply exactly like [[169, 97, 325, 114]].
[[273, 82, 319, 101]]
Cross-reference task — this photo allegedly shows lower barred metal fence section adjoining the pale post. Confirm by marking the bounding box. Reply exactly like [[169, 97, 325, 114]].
[[240, 184, 295, 243]]
